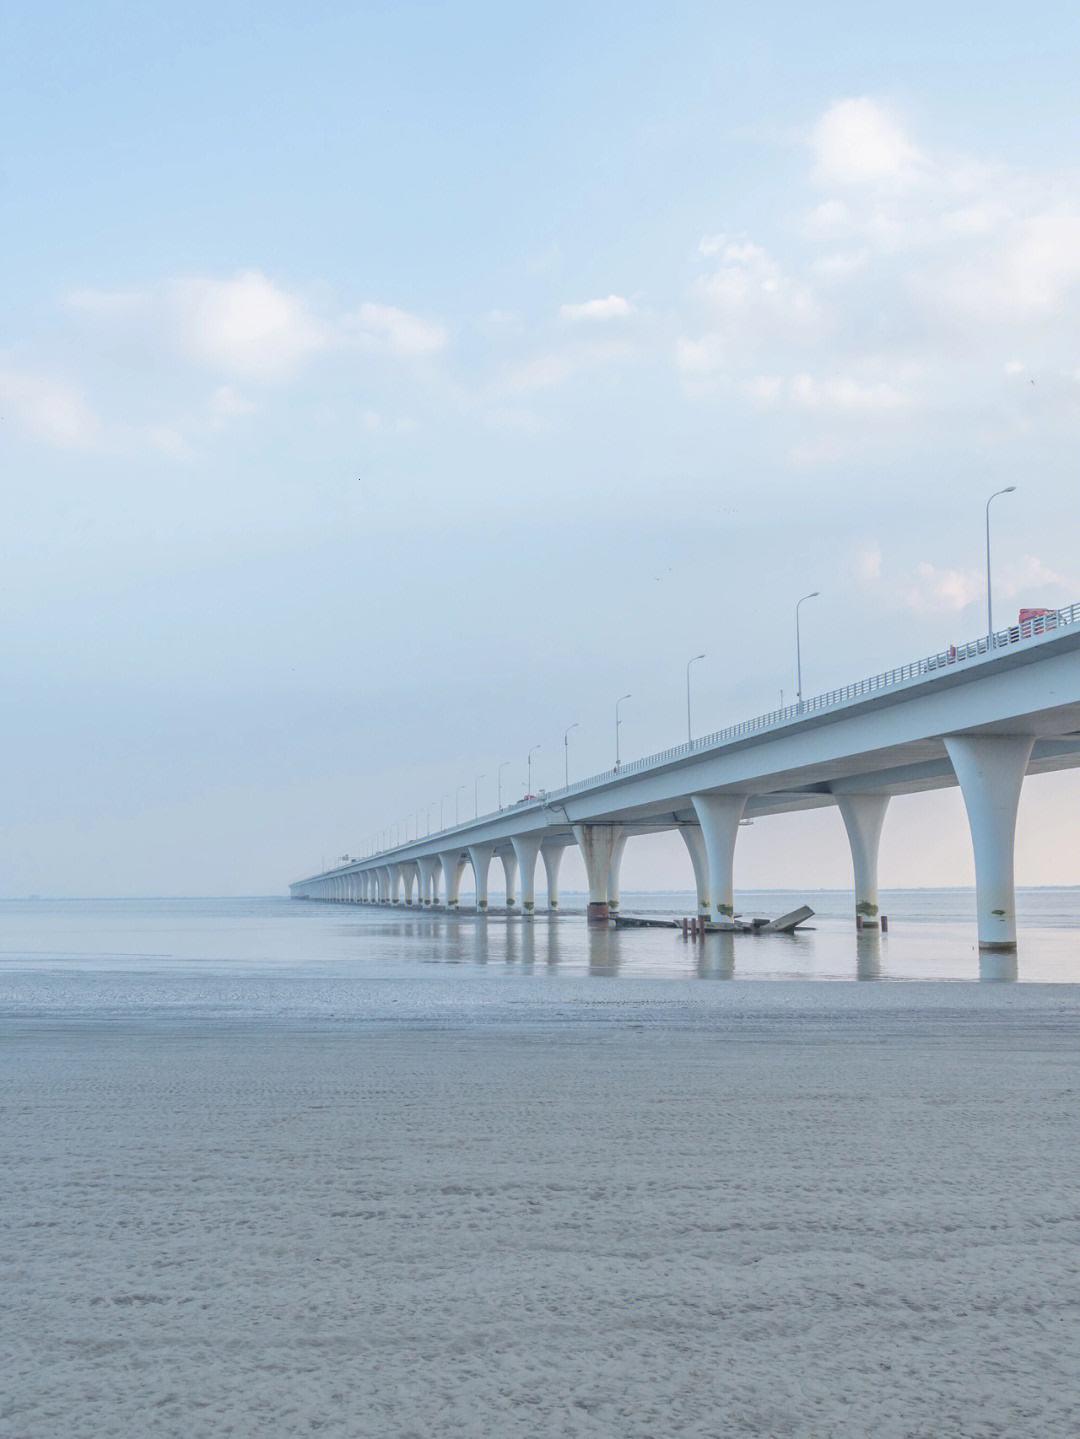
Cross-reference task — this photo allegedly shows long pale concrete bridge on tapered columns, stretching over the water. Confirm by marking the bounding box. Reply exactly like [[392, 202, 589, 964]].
[[290, 604, 1080, 950]]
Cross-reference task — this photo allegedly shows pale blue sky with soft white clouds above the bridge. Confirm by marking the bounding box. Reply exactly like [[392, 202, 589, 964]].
[[0, 3, 1080, 894]]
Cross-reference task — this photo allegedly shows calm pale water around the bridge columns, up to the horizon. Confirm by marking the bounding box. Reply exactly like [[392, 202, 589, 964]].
[[0, 888, 1080, 1023]]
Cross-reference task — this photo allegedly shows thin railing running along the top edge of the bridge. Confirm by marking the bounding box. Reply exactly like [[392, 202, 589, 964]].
[[339, 604, 1080, 872]]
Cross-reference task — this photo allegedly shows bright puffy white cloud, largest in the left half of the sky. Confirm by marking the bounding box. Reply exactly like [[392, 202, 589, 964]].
[[170, 271, 326, 380]]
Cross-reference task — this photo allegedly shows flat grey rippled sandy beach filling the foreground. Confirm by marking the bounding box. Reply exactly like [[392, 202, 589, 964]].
[[0, 984, 1080, 1439]]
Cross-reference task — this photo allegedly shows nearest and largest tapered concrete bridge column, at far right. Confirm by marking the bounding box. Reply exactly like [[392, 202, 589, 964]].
[[945, 734, 1035, 950]]
